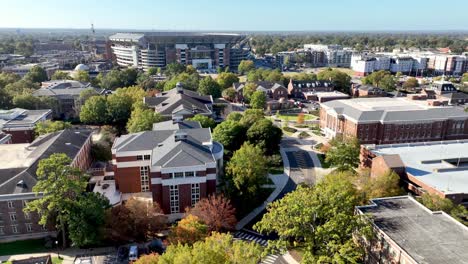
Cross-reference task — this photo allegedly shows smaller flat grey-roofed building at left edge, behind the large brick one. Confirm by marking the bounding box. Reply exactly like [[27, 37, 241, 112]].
[[0, 108, 52, 143]]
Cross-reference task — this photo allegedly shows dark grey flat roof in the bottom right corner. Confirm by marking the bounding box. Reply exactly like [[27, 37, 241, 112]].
[[357, 196, 468, 264]]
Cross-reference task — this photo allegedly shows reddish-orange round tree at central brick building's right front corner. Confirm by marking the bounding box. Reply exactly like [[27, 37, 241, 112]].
[[189, 195, 237, 232]]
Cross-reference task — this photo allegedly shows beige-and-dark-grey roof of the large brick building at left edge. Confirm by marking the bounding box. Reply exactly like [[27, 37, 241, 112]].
[[0, 129, 91, 196]]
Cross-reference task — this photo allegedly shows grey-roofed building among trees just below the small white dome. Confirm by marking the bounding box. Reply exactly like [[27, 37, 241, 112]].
[[33, 80, 103, 119]]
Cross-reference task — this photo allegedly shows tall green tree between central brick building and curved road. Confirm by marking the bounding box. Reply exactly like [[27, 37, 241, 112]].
[[226, 143, 268, 197]]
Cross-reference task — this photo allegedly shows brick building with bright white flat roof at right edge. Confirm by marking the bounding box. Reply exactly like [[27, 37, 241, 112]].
[[360, 140, 468, 206]]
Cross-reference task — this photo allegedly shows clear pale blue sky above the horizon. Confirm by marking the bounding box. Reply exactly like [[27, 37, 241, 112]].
[[0, 0, 468, 31]]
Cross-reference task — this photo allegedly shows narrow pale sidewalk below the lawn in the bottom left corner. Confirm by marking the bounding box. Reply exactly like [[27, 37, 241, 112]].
[[0, 247, 116, 264]]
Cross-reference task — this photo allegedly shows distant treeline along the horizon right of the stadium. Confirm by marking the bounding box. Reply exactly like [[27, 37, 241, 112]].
[[250, 33, 468, 55]]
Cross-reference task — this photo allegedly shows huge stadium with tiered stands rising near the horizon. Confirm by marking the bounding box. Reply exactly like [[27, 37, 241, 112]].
[[109, 32, 246, 70]]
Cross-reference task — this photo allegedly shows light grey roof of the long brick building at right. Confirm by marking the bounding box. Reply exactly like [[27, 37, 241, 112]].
[[321, 97, 468, 123]]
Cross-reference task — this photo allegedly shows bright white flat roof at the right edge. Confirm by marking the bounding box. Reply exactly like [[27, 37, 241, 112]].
[[364, 140, 468, 194]]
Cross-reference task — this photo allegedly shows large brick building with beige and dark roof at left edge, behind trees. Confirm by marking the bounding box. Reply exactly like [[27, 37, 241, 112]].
[[0, 129, 91, 242]]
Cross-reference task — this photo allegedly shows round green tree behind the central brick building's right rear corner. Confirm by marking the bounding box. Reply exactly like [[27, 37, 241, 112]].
[[213, 120, 245, 151]]
